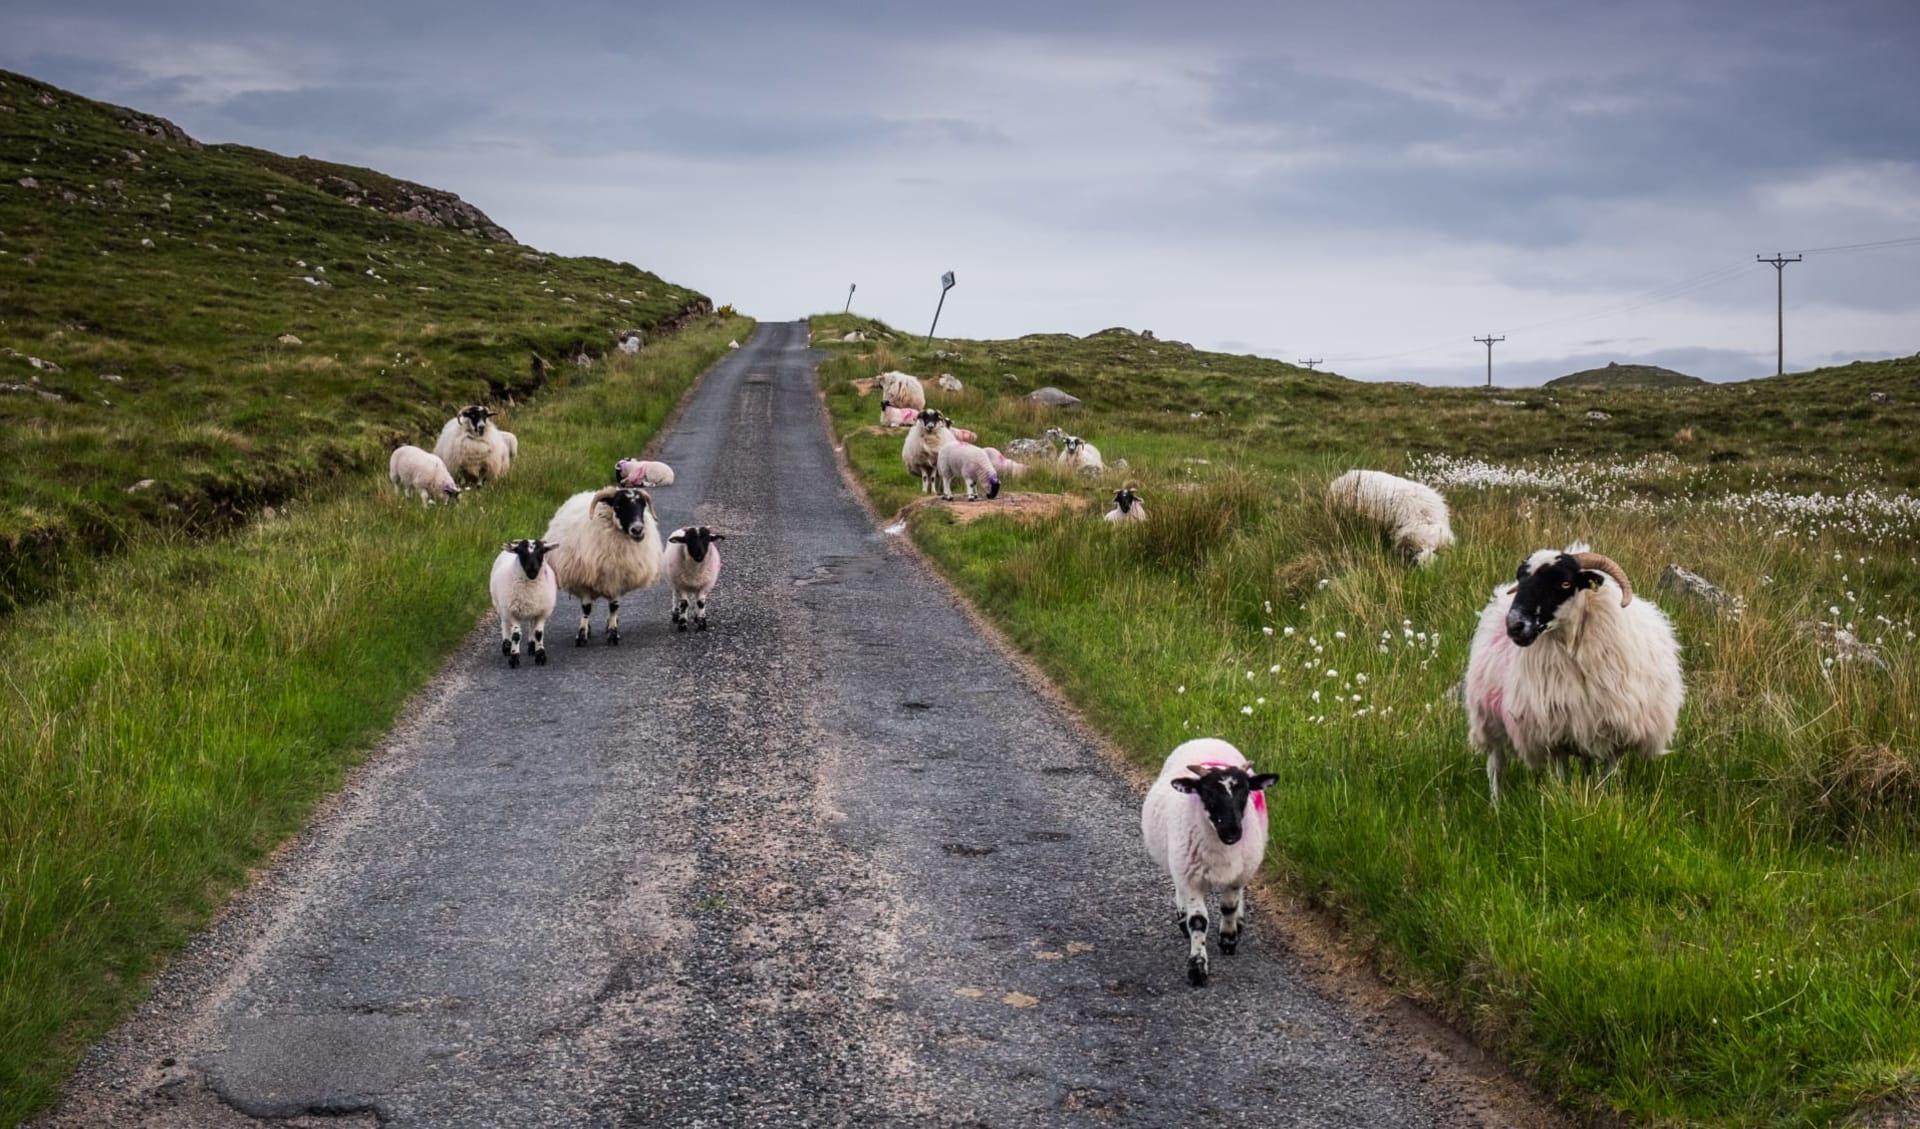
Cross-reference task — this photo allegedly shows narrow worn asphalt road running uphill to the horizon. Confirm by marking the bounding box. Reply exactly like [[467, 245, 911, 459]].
[[48, 324, 1543, 1129]]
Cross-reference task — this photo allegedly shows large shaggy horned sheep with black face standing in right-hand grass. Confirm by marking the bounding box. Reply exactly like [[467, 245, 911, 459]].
[[1465, 543, 1686, 803]]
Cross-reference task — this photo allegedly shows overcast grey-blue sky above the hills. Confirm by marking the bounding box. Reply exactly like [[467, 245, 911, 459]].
[[0, 0, 1920, 384]]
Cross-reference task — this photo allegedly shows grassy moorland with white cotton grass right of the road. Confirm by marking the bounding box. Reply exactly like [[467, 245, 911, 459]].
[[814, 317, 1920, 1125]]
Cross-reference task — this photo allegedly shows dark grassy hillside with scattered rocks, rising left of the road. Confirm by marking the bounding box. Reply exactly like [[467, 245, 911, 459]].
[[0, 71, 708, 614]]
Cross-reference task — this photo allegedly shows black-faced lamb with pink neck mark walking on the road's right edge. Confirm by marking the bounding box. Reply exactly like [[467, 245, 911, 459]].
[[1140, 737, 1279, 987]]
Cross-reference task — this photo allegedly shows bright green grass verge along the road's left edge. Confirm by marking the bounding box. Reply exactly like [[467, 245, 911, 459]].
[[0, 319, 751, 1125]]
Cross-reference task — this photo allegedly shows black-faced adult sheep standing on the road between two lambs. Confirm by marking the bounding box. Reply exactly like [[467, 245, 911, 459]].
[[541, 486, 660, 647]]
